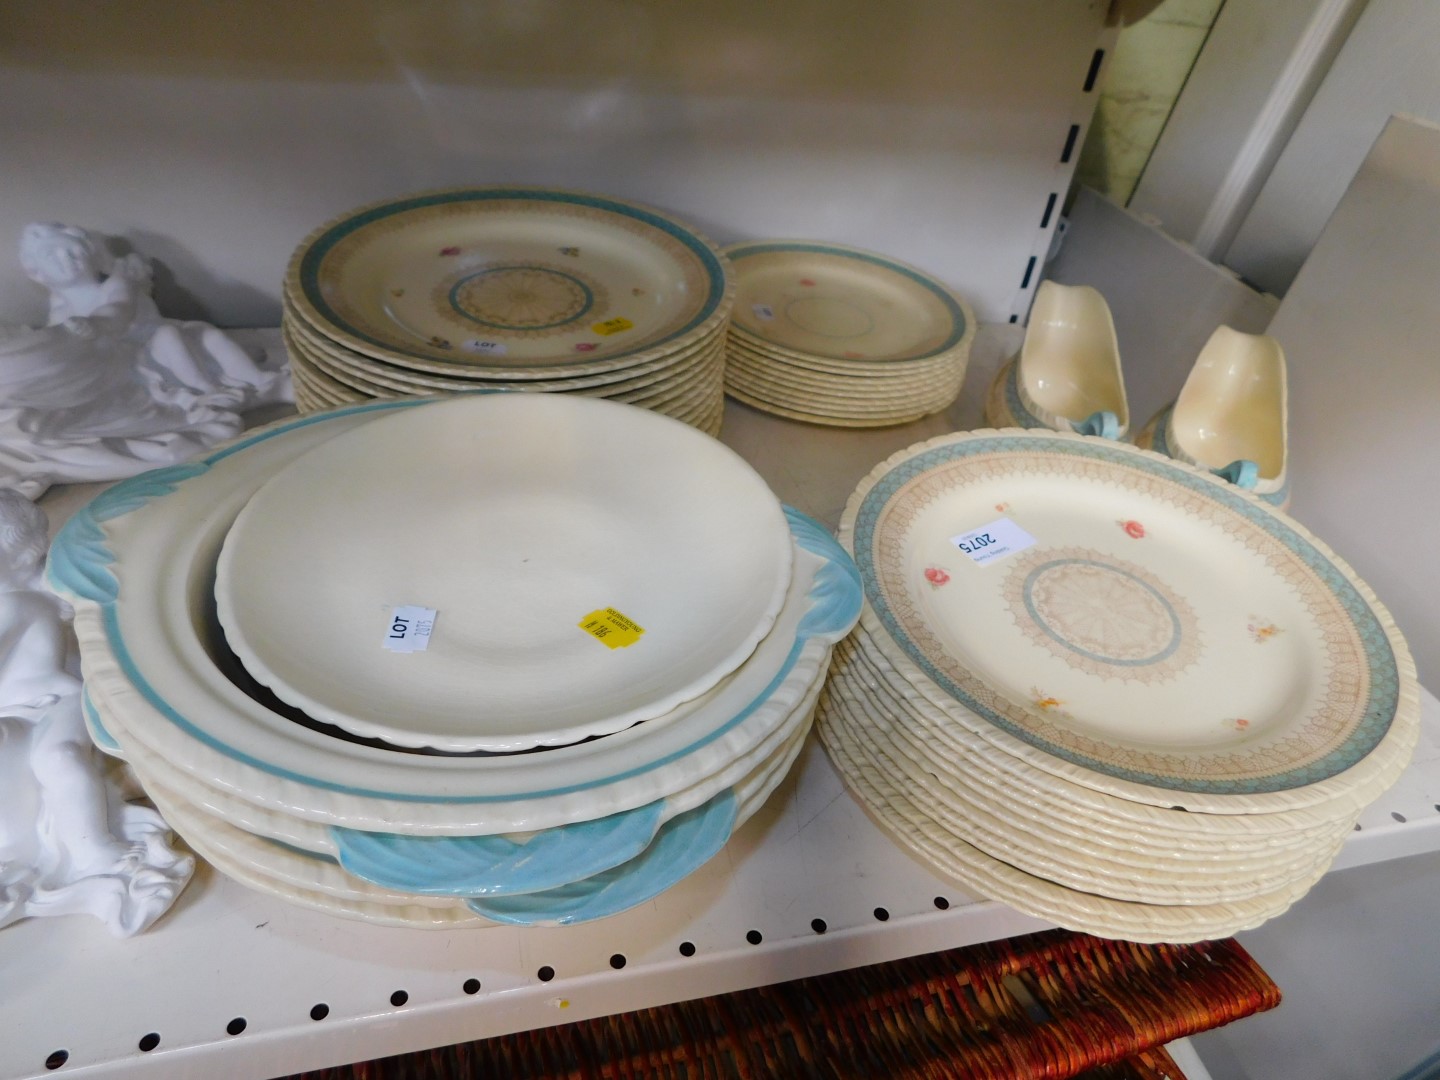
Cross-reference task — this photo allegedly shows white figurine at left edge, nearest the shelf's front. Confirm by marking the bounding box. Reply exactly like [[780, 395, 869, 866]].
[[0, 491, 194, 936]]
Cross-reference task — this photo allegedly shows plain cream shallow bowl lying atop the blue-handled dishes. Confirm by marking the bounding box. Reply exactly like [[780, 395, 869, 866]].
[[216, 393, 792, 752]]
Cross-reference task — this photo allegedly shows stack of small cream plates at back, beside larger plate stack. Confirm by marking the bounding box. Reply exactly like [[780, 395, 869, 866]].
[[724, 240, 975, 428]]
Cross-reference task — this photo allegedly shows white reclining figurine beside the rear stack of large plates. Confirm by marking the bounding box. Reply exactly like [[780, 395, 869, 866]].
[[0, 225, 292, 498]]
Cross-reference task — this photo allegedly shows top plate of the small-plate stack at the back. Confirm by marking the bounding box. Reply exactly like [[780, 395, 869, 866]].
[[726, 240, 975, 361]]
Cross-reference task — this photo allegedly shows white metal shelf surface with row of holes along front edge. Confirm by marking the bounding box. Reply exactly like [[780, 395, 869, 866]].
[[11, 327, 1440, 1079]]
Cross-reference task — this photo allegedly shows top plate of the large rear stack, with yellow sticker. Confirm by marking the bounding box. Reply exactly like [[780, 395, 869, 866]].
[[285, 187, 730, 379]]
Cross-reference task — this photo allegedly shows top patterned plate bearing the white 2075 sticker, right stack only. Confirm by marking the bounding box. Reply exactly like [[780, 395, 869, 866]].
[[841, 431, 1418, 812]]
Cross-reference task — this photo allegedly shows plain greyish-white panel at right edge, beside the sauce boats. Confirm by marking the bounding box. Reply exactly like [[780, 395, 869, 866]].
[[1270, 114, 1440, 685]]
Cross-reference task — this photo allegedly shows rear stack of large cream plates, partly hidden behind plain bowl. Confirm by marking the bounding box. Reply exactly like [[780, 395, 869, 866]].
[[282, 187, 732, 433]]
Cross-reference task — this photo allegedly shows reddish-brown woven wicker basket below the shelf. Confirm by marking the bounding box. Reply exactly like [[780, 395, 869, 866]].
[[275, 930, 1280, 1080]]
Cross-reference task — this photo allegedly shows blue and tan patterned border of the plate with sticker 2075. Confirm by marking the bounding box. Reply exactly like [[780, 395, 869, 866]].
[[854, 435, 1401, 793]]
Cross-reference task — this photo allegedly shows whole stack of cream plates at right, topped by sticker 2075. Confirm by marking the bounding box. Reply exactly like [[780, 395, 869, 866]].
[[818, 431, 1418, 942]]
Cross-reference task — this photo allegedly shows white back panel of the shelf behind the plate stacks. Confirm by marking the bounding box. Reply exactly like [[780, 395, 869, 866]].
[[0, 0, 1107, 325]]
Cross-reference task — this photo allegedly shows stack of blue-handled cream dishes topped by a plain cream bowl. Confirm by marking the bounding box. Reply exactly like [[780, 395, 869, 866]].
[[49, 393, 860, 926]]
